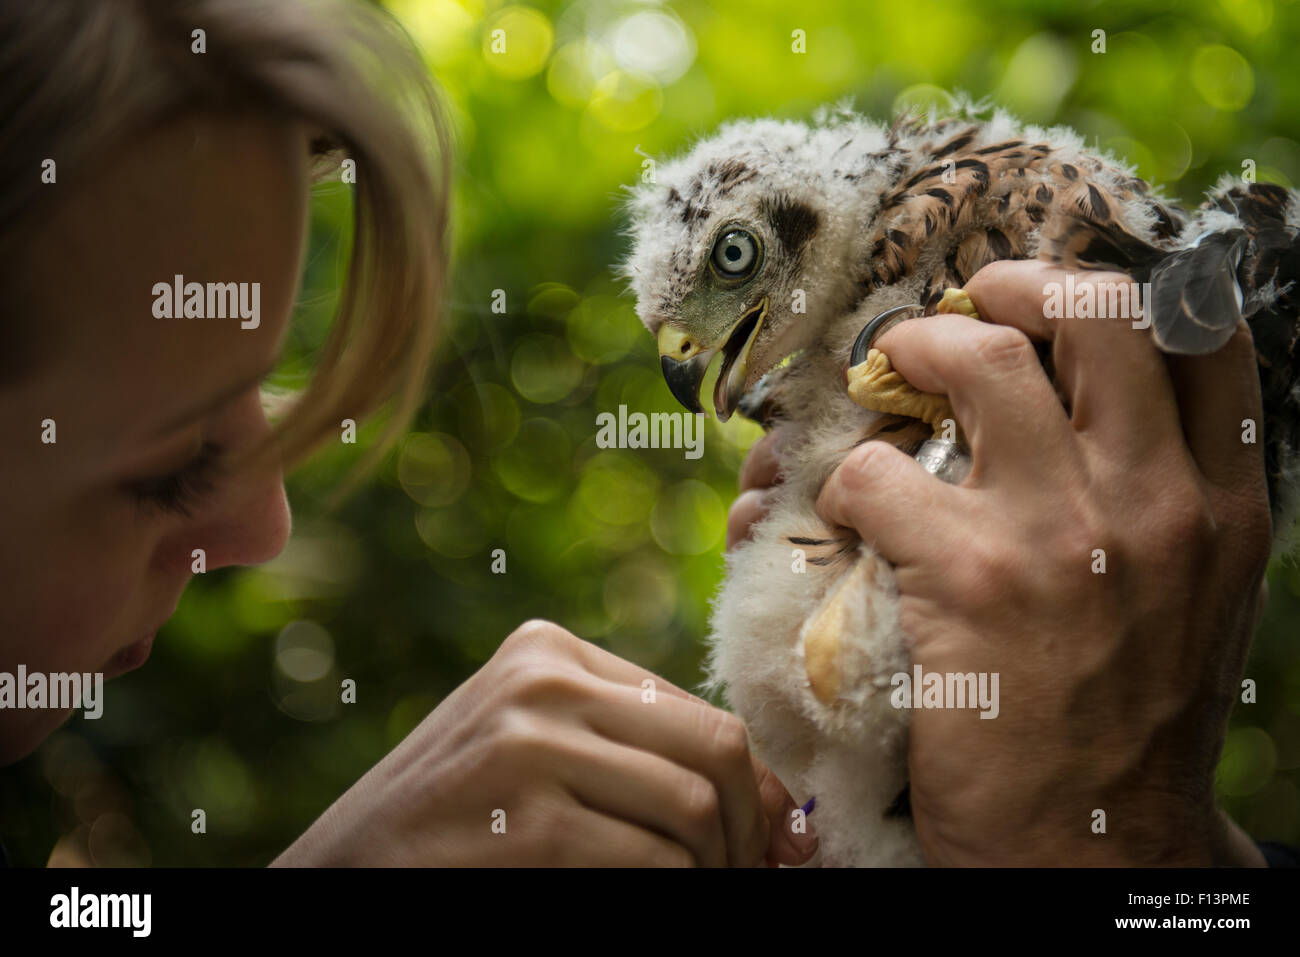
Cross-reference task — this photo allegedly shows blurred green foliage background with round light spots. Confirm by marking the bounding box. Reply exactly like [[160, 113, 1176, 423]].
[[0, 0, 1300, 865]]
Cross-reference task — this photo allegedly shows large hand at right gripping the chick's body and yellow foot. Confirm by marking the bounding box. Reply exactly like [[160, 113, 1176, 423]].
[[818, 263, 1271, 865]]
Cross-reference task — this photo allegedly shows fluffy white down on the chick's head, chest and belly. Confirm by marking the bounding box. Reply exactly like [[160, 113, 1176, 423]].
[[623, 98, 1289, 866]]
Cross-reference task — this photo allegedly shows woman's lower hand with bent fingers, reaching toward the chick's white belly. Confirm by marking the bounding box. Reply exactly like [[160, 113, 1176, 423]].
[[276, 622, 816, 866]]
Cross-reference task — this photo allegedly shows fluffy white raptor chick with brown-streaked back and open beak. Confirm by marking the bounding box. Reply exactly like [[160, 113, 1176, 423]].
[[623, 108, 1300, 865]]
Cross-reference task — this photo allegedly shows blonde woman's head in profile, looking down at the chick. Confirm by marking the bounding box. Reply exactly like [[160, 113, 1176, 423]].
[[0, 0, 449, 763]]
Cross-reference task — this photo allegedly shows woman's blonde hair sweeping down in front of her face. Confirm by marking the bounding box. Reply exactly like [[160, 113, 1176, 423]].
[[0, 0, 451, 486]]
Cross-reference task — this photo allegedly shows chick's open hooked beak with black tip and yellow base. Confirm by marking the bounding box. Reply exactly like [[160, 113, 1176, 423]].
[[659, 296, 767, 421]]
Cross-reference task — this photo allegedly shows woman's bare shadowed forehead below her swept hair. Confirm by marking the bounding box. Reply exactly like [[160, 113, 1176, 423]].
[[8, 114, 308, 449]]
